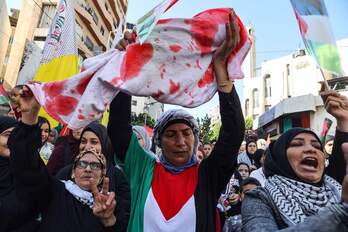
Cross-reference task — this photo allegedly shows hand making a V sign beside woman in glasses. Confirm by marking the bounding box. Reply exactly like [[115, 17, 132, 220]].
[[91, 177, 116, 226]]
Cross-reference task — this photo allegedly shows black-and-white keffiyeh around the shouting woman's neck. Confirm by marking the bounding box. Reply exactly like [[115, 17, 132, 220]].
[[265, 175, 342, 225]]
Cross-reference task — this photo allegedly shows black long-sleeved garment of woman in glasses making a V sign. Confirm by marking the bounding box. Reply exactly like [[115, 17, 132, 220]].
[[8, 123, 117, 232]]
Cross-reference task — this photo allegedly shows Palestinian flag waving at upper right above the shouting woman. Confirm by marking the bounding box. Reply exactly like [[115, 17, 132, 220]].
[[290, 0, 342, 76]]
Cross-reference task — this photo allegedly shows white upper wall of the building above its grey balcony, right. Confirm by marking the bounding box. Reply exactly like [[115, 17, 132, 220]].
[[242, 38, 348, 120]]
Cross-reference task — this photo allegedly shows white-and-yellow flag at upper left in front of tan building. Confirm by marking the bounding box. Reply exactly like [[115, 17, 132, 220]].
[[34, 0, 78, 127]]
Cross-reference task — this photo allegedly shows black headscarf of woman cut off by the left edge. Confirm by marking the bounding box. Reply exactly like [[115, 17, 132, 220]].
[[0, 116, 17, 197]]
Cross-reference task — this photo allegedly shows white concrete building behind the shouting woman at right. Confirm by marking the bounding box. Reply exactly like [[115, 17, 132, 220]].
[[242, 39, 348, 136]]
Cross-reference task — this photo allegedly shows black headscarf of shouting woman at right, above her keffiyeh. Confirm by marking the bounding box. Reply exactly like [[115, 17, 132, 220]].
[[264, 128, 324, 185]]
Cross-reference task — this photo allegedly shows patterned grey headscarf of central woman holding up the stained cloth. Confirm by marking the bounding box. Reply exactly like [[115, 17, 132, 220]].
[[154, 109, 199, 174]]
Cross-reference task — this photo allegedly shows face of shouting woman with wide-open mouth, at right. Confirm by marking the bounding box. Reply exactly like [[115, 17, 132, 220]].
[[287, 133, 325, 183]]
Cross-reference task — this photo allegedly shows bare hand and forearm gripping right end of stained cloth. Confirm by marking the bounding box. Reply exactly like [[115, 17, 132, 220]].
[[213, 12, 240, 93]]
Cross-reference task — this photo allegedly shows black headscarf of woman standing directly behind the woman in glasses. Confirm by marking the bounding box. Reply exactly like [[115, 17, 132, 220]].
[[80, 121, 114, 166]]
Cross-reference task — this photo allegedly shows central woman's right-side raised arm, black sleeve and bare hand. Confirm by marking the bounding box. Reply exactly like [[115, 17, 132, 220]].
[[202, 10, 245, 192]]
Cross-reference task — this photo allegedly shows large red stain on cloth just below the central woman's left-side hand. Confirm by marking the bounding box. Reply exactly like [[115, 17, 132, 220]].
[[121, 43, 153, 80]]
